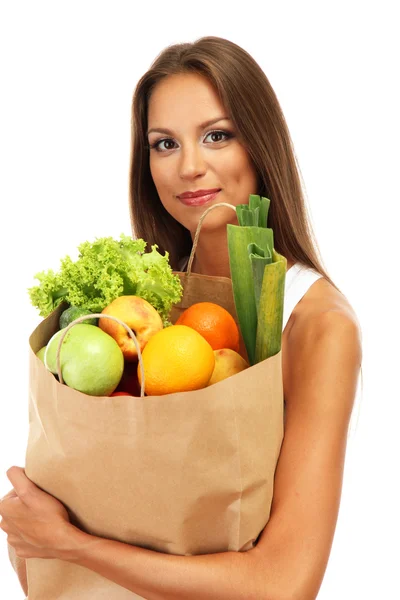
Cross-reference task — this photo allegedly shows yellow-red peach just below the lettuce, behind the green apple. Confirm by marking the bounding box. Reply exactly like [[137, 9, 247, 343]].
[[99, 296, 163, 362]]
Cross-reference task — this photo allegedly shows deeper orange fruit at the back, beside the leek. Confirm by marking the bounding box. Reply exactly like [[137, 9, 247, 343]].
[[176, 302, 239, 352]]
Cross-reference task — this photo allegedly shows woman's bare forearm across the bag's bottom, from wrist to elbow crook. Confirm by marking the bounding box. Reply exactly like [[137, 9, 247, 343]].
[[60, 528, 262, 600]]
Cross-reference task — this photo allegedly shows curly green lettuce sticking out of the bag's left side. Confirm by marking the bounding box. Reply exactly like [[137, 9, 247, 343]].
[[28, 234, 183, 325]]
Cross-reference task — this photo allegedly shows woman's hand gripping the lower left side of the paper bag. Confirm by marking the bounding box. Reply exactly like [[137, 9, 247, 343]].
[[0, 467, 73, 558]]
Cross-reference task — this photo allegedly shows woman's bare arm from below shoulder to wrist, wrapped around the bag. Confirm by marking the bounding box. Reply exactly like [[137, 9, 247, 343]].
[[57, 311, 361, 600]]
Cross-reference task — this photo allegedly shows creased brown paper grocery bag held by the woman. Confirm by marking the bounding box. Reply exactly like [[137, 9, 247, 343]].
[[20, 273, 283, 600]]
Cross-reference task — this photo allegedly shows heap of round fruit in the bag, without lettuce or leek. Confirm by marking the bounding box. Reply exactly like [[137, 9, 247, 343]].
[[37, 295, 249, 396]]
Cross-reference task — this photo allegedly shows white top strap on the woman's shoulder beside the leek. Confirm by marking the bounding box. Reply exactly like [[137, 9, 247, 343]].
[[179, 256, 322, 331]]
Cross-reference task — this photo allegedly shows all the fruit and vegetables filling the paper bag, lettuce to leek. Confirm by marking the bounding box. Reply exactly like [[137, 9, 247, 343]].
[[29, 195, 287, 396]]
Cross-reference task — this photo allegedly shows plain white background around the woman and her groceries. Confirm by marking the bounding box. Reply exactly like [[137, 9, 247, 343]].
[[0, 0, 400, 600]]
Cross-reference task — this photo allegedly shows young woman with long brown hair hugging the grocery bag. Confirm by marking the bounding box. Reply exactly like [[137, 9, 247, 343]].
[[0, 37, 362, 600]]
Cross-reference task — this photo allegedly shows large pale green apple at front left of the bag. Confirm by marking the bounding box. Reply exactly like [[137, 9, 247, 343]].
[[44, 323, 124, 396]]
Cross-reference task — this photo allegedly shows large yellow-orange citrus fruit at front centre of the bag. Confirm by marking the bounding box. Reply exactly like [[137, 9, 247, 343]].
[[138, 325, 215, 396]]
